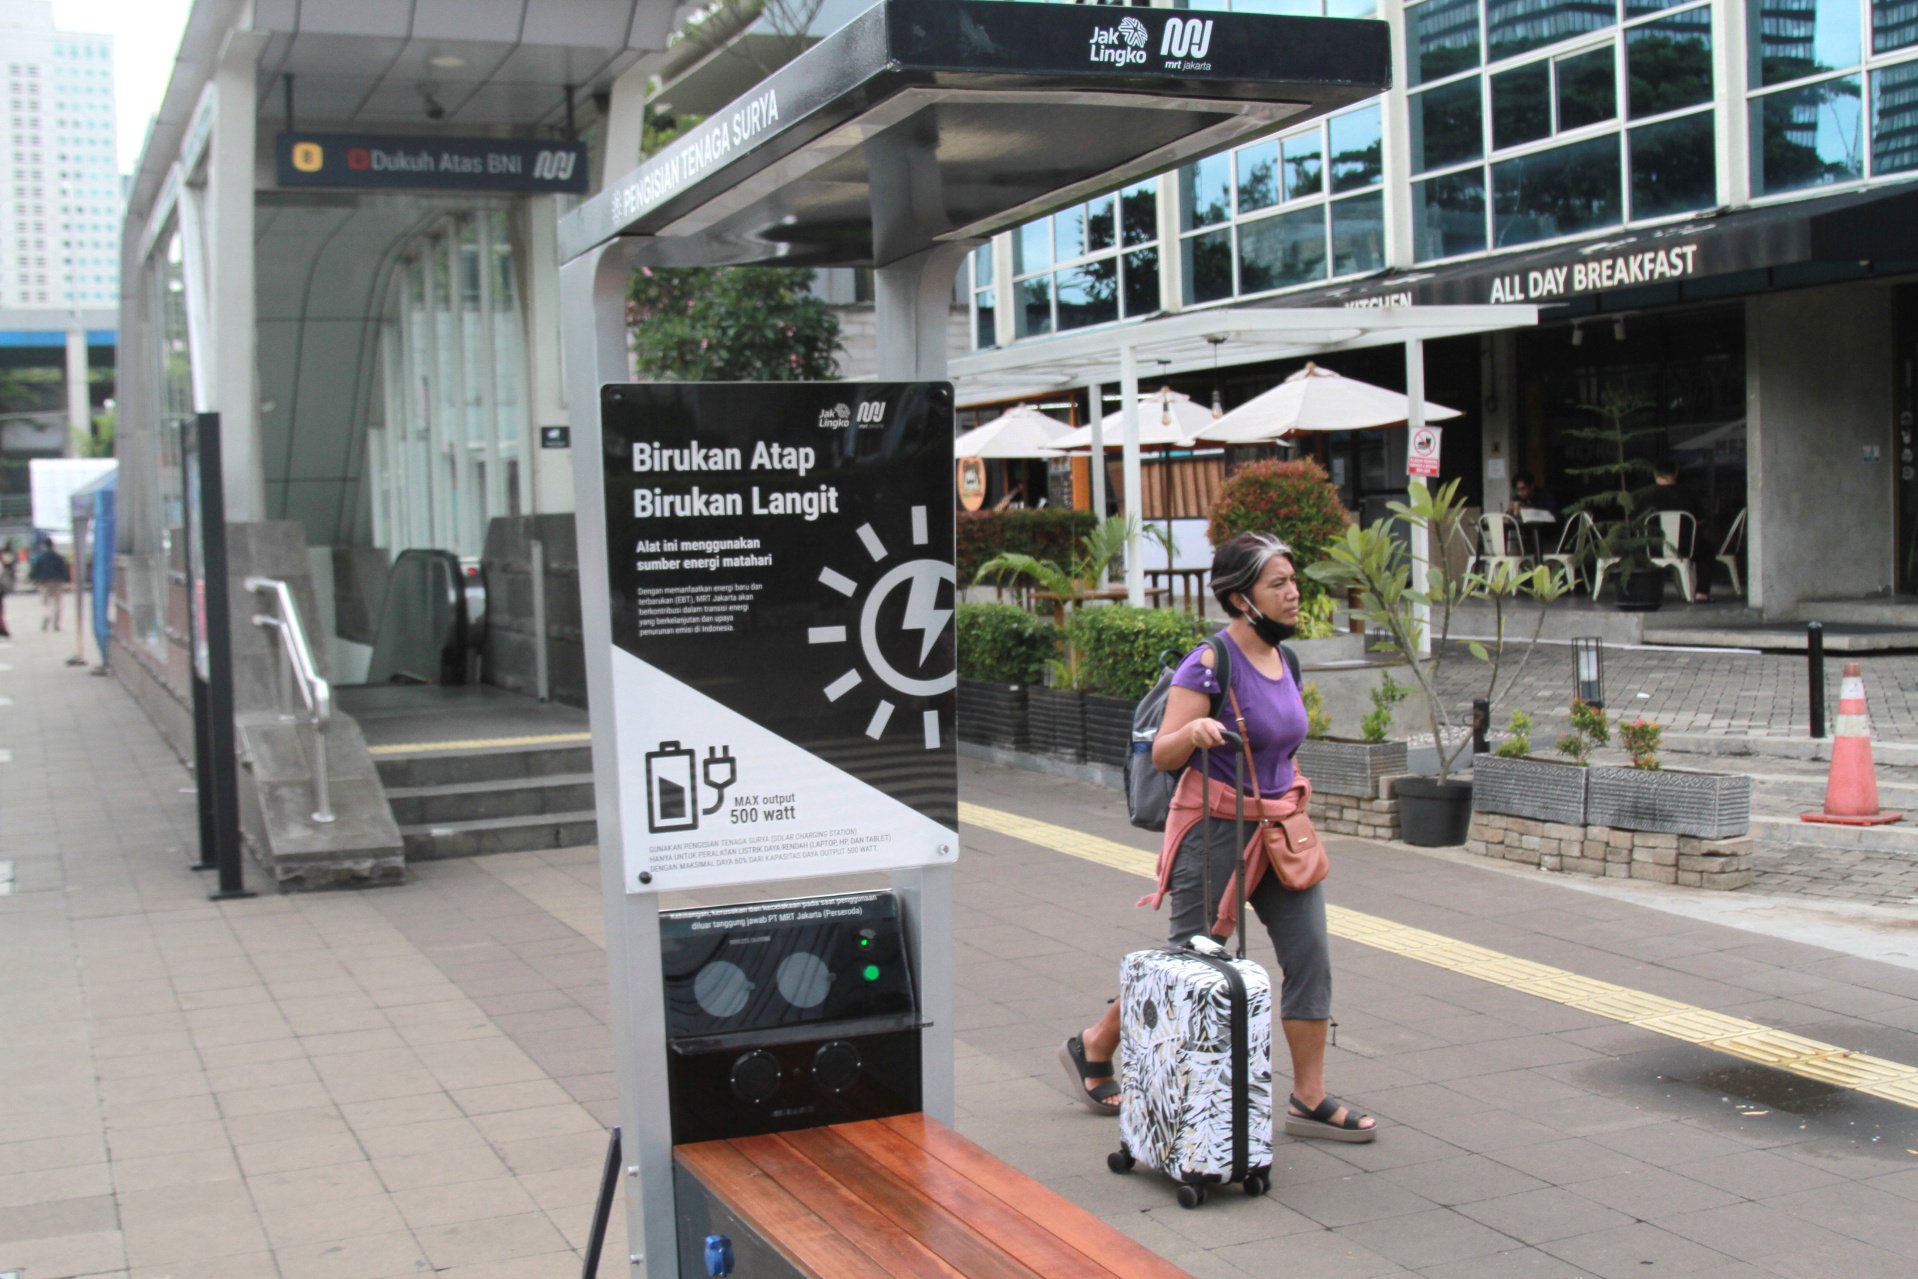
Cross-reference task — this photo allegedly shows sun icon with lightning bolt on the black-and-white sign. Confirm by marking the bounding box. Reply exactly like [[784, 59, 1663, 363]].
[[806, 506, 959, 750]]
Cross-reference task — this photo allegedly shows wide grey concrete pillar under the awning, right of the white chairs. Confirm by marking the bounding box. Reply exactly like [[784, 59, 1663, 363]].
[[1749, 284, 1897, 617]]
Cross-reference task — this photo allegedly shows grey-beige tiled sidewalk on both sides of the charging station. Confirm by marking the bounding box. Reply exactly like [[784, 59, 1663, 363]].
[[0, 621, 1918, 1279]]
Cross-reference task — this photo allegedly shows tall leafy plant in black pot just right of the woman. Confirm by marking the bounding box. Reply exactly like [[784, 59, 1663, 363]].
[[1306, 479, 1567, 846]]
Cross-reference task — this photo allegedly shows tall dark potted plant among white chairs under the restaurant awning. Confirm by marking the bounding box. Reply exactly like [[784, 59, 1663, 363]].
[[1563, 391, 1665, 612]]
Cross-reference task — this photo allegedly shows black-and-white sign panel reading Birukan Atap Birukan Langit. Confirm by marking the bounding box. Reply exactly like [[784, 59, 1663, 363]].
[[600, 384, 957, 892]]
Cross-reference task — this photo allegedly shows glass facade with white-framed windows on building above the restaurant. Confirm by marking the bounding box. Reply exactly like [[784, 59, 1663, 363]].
[[972, 0, 1918, 349]]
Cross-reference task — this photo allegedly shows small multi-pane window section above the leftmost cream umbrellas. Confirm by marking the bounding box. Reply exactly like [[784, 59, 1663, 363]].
[[1012, 182, 1158, 345]]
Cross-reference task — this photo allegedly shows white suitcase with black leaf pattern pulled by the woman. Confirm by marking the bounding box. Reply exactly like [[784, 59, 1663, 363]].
[[1107, 734, 1272, 1208]]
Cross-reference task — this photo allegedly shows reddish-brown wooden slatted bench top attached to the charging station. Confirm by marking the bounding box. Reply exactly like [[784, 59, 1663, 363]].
[[673, 1114, 1191, 1279]]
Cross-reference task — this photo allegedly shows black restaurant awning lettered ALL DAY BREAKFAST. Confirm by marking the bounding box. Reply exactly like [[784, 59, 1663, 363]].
[[1266, 186, 1918, 313]]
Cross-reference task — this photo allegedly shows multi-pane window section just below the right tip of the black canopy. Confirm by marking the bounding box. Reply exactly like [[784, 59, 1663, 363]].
[[1178, 104, 1385, 305]]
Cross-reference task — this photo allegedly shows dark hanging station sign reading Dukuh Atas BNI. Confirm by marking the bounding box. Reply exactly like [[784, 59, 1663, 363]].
[[276, 132, 587, 194]]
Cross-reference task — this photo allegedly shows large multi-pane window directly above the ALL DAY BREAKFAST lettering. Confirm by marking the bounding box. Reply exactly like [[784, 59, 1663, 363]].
[[1406, 0, 1719, 263]]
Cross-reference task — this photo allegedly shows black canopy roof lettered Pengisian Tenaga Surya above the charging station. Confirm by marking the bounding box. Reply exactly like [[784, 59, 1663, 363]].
[[560, 0, 1391, 267]]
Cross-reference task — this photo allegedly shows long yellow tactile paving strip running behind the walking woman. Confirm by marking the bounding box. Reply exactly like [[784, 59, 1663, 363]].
[[959, 803, 1918, 1110]]
